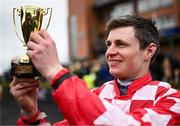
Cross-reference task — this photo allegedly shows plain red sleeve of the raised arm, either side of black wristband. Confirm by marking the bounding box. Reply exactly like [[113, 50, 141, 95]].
[[51, 69, 106, 124]]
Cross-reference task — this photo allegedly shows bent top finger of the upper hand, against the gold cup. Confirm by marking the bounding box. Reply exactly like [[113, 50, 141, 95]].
[[29, 32, 44, 44]]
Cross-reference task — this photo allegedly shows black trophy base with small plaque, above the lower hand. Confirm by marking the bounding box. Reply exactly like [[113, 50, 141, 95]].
[[11, 57, 40, 78]]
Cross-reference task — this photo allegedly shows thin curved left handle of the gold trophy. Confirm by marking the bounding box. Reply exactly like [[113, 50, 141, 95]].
[[13, 8, 26, 46]]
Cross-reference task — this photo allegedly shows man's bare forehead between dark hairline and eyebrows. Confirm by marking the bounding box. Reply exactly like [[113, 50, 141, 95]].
[[107, 26, 138, 42]]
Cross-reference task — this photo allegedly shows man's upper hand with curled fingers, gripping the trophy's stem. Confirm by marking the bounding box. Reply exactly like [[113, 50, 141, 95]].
[[27, 30, 62, 80]]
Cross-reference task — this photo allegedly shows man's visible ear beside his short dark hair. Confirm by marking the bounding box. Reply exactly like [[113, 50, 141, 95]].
[[144, 43, 157, 61]]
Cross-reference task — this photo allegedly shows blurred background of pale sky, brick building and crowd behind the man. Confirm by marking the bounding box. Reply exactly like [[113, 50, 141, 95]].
[[0, 0, 180, 125]]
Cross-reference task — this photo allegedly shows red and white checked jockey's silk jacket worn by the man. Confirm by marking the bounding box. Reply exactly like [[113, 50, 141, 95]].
[[51, 69, 180, 126]]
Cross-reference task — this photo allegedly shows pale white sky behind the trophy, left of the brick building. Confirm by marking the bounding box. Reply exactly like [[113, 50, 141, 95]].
[[0, 0, 70, 74]]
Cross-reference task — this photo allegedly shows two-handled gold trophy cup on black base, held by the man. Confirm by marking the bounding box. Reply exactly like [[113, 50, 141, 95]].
[[11, 6, 52, 77]]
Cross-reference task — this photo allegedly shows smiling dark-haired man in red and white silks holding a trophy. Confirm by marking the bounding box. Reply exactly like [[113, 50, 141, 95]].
[[10, 16, 180, 125]]
